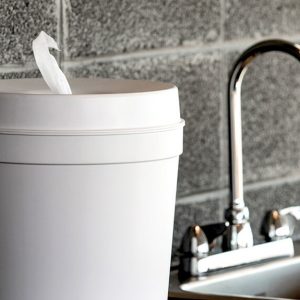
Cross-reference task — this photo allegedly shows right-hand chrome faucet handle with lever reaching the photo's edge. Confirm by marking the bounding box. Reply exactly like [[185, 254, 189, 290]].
[[261, 206, 300, 242]]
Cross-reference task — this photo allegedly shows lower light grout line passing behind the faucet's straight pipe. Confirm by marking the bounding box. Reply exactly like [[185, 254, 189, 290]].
[[176, 174, 300, 205]]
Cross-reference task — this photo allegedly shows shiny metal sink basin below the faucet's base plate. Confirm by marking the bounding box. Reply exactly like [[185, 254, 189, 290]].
[[171, 245, 300, 299]]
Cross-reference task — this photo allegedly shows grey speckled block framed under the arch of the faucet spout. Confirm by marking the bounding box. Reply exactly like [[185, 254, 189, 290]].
[[228, 52, 300, 182]]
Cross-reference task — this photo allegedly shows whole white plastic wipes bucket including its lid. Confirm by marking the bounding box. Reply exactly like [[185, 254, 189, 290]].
[[0, 79, 184, 300]]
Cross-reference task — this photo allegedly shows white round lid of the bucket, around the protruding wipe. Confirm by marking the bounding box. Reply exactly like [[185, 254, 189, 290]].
[[0, 78, 180, 134]]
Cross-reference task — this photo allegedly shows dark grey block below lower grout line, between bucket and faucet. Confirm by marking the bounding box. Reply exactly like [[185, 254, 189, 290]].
[[172, 199, 224, 253]]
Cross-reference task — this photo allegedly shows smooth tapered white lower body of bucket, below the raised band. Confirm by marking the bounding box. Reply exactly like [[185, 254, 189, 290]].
[[0, 157, 178, 300]]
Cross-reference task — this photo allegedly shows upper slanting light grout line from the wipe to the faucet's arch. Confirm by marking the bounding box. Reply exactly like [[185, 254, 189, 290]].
[[63, 33, 300, 67]]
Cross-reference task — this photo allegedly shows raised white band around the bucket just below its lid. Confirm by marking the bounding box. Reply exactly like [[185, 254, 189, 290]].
[[0, 122, 183, 164]]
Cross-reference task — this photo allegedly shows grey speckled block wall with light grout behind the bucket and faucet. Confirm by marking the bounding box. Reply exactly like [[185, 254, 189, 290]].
[[0, 0, 300, 255]]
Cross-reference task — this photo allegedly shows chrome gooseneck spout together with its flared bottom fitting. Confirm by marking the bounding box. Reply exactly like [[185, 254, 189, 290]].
[[223, 40, 300, 250]]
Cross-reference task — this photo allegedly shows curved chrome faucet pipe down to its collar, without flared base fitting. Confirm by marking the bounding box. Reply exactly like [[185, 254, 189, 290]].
[[227, 40, 300, 224]]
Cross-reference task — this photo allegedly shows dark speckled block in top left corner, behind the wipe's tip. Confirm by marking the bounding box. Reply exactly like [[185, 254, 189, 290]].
[[0, 0, 58, 64]]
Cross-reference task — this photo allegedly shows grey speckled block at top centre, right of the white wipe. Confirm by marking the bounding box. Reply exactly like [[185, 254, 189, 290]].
[[66, 0, 221, 58]]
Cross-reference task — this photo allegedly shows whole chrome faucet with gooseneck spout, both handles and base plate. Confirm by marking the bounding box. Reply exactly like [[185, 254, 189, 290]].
[[179, 40, 300, 278]]
